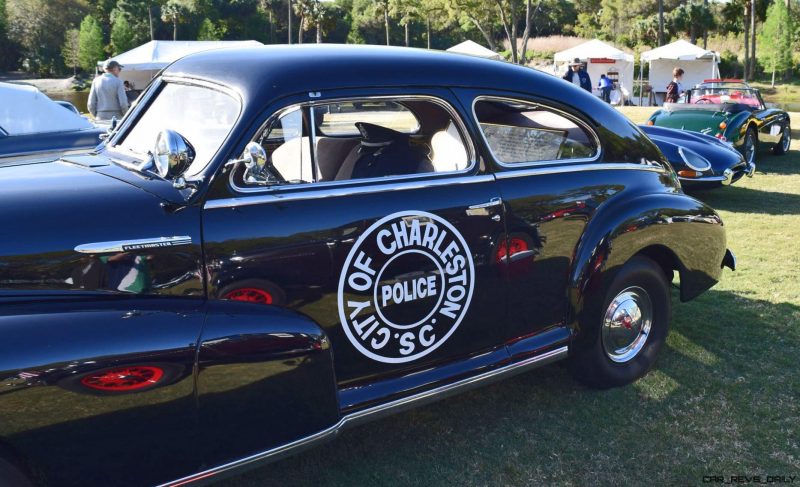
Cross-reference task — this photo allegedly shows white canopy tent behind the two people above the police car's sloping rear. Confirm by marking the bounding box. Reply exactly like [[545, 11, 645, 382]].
[[553, 39, 634, 104]]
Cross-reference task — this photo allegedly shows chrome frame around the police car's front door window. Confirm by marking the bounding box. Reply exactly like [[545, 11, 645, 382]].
[[228, 95, 478, 194]]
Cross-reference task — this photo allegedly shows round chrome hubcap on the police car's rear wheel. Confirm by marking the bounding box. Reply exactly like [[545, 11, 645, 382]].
[[602, 286, 653, 363]]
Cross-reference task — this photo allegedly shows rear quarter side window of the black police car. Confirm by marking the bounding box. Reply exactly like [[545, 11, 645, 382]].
[[475, 98, 599, 165]]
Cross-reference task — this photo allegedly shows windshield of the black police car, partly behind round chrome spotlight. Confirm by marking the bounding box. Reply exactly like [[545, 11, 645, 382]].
[[119, 83, 239, 177]]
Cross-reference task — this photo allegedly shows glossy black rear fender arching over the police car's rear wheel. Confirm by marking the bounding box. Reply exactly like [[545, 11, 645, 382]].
[[569, 193, 726, 326]]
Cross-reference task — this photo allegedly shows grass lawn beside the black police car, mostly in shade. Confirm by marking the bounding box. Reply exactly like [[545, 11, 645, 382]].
[[220, 108, 800, 487]]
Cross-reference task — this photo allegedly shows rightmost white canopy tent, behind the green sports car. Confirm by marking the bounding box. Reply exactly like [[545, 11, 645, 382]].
[[639, 39, 719, 105]]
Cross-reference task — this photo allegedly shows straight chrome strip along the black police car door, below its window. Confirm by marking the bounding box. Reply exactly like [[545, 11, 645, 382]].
[[203, 173, 493, 210]]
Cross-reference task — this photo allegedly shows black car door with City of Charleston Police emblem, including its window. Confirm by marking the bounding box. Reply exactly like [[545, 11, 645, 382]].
[[203, 90, 506, 410]]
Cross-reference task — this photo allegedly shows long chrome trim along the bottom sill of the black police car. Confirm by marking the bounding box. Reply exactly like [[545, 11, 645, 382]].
[[159, 346, 568, 487]]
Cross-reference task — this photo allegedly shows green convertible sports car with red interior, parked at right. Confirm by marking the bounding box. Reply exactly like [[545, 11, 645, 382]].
[[647, 79, 792, 164]]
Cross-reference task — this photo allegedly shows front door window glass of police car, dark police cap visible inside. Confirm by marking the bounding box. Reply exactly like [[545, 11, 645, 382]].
[[242, 98, 473, 186]]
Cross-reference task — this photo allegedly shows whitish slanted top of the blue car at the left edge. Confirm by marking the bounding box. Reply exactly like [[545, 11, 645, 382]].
[[0, 83, 92, 135]]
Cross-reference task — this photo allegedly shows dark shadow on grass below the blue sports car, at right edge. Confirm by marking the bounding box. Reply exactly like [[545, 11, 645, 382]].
[[684, 184, 800, 215]]
